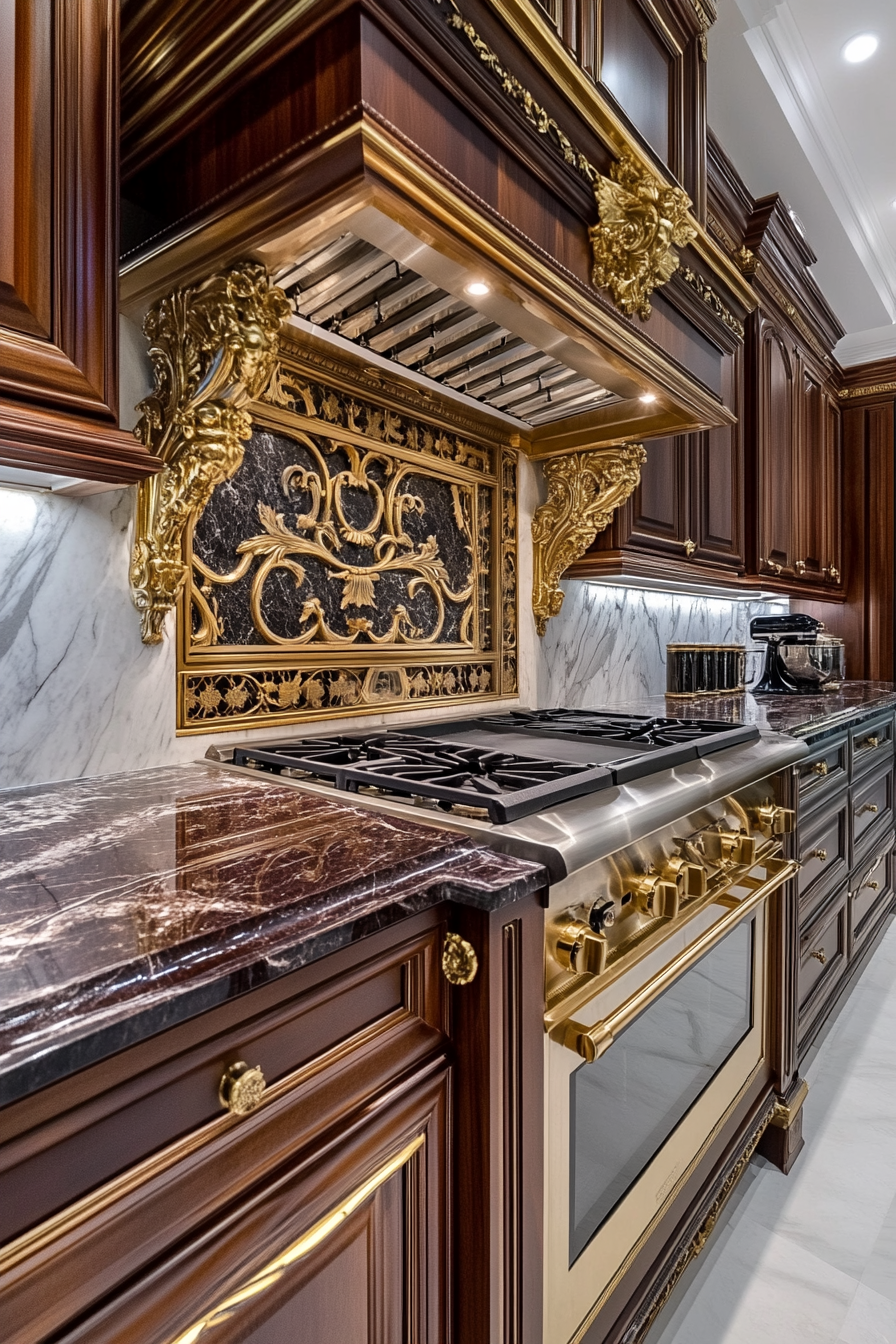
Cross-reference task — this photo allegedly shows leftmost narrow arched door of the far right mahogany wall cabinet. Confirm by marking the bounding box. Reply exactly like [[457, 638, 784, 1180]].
[[758, 323, 795, 577]]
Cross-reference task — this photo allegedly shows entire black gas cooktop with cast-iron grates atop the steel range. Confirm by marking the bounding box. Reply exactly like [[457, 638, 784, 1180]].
[[232, 710, 759, 825]]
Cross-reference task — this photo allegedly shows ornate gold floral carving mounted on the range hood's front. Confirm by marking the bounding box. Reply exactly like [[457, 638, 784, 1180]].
[[590, 149, 697, 319]]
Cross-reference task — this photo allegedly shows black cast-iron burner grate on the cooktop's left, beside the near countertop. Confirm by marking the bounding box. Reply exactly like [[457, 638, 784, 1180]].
[[234, 732, 614, 824]]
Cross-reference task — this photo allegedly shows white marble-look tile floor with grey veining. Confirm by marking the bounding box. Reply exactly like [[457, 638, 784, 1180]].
[[649, 925, 896, 1344]]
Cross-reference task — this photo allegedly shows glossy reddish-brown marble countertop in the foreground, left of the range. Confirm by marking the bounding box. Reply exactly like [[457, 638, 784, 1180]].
[[0, 765, 547, 1105]]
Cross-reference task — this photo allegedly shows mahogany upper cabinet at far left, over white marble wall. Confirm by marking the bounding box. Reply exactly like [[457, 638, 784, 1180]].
[[0, 0, 156, 482]]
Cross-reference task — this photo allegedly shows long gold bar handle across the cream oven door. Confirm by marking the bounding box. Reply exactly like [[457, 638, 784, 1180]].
[[551, 859, 799, 1063]]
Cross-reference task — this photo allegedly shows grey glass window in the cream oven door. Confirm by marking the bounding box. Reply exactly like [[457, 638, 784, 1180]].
[[570, 921, 755, 1265]]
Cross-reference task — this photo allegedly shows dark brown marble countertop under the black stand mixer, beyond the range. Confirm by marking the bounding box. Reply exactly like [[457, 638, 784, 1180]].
[[602, 681, 896, 738]]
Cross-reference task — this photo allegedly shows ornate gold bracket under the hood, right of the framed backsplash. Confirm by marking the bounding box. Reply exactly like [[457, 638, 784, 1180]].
[[532, 444, 647, 634]]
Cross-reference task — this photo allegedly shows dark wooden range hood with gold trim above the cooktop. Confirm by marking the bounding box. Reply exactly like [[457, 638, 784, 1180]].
[[121, 0, 755, 625]]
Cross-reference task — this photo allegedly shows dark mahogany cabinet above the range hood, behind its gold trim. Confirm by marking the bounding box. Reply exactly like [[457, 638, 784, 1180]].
[[532, 0, 716, 209]]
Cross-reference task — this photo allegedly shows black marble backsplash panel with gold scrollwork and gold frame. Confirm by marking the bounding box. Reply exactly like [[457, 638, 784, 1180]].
[[177, 328, 517, 734]]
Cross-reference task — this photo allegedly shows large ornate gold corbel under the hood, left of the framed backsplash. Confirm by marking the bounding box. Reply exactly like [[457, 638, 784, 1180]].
[[130, 262, 289, 644]]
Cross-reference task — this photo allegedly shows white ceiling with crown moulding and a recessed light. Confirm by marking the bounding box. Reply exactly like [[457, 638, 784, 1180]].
[[708, 0, 896, 363]]
